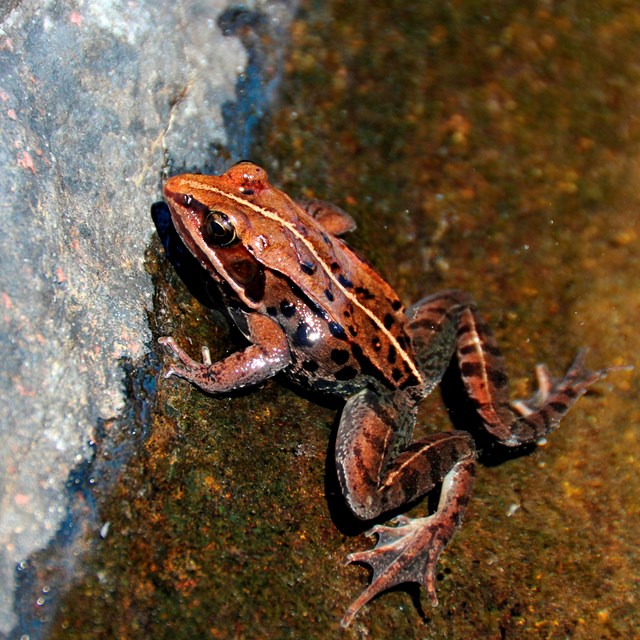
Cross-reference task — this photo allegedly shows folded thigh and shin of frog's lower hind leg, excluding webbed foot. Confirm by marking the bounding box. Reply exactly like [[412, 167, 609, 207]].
[[336, 391, 475, 520]]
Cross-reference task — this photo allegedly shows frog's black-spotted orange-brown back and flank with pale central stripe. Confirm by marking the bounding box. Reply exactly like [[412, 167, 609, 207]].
[[248, 199, 420, 393]]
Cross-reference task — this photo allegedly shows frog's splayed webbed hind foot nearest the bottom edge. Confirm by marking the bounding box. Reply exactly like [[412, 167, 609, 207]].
[[340, 511, 457, 627]]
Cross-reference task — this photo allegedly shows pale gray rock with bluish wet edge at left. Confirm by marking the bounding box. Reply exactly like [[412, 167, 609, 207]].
[[0, 0, 294, 634]]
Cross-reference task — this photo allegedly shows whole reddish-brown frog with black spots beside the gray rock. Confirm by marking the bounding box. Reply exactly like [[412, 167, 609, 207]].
[[160, 162, 608, 626]]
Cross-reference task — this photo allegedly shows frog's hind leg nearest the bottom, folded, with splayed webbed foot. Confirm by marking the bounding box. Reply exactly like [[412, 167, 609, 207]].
[[336, 390, 475, 627]]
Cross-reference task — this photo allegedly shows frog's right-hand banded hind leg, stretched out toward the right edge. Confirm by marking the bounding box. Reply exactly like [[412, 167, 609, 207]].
[[409, 290, 609, 447]]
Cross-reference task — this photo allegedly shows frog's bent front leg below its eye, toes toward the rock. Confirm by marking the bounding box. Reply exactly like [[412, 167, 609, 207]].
[[158, 313, 291, 393]]
